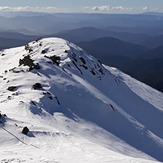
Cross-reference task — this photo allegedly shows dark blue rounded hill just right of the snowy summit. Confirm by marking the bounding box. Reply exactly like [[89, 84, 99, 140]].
[[77, 37, 147, 61]]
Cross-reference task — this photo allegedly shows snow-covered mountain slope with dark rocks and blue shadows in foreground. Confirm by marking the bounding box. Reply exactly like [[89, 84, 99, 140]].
[[0, 38, 163, 163]]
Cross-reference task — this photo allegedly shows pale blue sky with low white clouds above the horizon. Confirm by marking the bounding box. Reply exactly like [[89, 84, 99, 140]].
[[0, 0, 163, 13]]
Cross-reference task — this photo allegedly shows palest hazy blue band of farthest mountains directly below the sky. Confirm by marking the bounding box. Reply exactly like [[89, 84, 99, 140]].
[[0, 12, 163, 34]]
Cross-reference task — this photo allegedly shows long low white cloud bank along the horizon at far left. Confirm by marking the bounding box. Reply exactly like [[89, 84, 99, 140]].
[[0, 6, 57, 12]]
